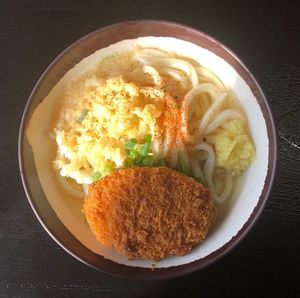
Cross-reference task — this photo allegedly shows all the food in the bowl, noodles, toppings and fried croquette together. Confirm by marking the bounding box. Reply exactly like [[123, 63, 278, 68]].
[[49, 47, 255, 260]]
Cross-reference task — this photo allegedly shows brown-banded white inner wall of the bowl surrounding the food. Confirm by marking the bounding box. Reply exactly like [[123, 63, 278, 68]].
[[19, 21, 276, 276]]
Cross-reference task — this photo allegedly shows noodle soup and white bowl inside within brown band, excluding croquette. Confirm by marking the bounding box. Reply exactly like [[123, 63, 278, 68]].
[[27, 37, 268, 268]]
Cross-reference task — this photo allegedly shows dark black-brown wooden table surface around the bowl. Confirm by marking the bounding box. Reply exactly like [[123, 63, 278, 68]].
[[0, 0, 300, 297]]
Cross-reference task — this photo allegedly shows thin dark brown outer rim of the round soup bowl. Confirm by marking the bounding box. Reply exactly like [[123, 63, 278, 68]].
[[18, 19, 277, 280]]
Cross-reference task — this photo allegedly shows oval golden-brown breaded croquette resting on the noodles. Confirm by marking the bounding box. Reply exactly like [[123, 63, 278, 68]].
[[84, 167, 216, 260]]
